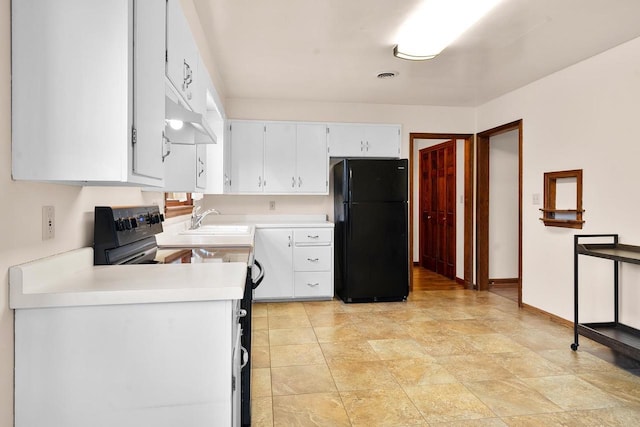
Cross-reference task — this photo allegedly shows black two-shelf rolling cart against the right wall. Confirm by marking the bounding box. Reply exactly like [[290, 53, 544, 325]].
[[571, 234, 640, 360]]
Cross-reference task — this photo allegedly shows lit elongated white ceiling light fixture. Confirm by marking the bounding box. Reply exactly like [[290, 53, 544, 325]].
[[393, 0, 501, 61]]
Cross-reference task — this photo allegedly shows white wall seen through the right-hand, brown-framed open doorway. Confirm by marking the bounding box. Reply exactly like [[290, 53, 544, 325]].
[[489, 130, 520, 279]]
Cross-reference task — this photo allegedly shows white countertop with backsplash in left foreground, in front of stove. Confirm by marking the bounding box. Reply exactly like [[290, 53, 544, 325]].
[[9, 248, 247, 309]]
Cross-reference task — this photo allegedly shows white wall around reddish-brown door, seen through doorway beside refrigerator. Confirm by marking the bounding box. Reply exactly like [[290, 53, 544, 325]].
[[413, 139, 464, 279]]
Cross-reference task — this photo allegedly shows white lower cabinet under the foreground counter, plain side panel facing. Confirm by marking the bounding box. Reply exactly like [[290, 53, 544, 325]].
[[15, 300, 242, 427]]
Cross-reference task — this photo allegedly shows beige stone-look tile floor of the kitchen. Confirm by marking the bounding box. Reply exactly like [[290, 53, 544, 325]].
[[252, 290, 640, 427]]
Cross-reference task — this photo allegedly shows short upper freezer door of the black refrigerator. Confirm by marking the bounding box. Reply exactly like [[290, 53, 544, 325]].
[[345, 159, 409, 202]]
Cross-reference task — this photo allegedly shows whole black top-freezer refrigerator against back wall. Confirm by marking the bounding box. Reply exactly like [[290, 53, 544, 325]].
[[333, 159, 409, 302]]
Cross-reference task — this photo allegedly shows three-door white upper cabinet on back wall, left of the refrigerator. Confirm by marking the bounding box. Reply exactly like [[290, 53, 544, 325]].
[[229, 121, 329, 194]]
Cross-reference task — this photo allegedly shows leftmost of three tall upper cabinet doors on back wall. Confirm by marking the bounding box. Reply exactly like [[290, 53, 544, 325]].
[[231, 122, 264, 193]]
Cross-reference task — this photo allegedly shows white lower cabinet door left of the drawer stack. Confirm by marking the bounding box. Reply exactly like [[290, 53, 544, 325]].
[[253, 228, 293, 300]]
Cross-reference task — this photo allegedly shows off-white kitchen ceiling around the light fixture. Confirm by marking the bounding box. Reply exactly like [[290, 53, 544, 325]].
[[193, 0, 640, 106]]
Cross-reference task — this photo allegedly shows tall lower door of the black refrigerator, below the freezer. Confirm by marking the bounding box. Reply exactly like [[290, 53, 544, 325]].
[[336, 202, 409, 302]]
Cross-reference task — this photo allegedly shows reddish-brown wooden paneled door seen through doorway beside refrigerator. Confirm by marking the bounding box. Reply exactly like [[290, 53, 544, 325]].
[[420, 140, 456, 279]]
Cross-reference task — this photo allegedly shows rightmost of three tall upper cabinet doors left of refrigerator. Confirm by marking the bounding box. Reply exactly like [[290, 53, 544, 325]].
[[295, 123, 329, 194]]
